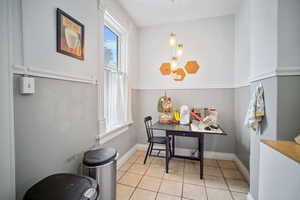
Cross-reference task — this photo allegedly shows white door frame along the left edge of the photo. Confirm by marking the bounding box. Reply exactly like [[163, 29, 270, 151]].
[[0, 0, 15, 200]]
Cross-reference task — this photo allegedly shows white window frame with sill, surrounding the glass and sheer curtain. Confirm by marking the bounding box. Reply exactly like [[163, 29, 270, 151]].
[[100, 11, 132, 140]]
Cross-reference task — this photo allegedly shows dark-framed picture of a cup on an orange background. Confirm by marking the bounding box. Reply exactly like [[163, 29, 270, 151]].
[[56, 8, 84, 60]]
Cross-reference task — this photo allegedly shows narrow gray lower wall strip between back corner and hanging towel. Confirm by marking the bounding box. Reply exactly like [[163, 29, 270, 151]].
[[234, 86, 250, 169]]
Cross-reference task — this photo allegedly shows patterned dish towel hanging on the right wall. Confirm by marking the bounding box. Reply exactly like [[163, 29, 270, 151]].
[[245, 83, 265, 134]]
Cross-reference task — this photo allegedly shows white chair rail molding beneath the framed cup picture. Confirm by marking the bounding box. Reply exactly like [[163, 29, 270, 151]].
[[12, 65, 97, 84]]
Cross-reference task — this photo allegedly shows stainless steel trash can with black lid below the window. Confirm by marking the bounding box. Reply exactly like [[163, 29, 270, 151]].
[[83, 148, 118, 200]]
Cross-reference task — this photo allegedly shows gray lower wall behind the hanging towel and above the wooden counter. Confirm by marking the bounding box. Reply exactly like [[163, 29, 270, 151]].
[[250, 76, 300, 199]]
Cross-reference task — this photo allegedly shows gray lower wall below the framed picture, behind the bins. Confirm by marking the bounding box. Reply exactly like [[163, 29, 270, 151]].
[[14, 76, 97, 199]]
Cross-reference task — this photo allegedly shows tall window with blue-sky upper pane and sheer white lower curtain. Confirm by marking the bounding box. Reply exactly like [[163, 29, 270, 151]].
[[104, 12, 128, 131]]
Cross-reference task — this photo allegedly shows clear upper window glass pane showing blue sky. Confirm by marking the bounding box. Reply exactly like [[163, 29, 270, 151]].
[[104, 26, 119, 70]]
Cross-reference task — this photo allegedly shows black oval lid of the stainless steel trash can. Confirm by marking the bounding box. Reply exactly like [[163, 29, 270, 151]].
[[83, 148, 117, 167]]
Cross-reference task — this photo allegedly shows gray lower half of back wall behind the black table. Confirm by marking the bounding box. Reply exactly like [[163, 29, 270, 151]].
[[133, 89, 235, 153]]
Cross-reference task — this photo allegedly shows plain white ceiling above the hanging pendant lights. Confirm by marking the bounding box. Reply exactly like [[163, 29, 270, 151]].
[[118, 0, 240, 27]]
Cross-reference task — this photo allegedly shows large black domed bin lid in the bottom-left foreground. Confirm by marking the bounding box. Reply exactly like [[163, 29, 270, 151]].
[[23, 174, 98, 200]]
